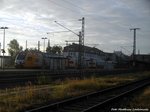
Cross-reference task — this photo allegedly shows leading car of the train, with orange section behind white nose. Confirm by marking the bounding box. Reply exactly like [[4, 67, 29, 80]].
[[15, 51, 67, 70]]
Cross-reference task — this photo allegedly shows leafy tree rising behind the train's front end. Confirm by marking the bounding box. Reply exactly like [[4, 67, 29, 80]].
[[8, 39, 23, 59]]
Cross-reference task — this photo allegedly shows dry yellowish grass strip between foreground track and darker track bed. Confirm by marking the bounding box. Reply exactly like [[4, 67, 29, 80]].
[[0, 72, 150, 112]]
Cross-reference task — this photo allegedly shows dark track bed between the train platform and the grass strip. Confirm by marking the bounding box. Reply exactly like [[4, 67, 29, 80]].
[[0, 69, 135, 89]]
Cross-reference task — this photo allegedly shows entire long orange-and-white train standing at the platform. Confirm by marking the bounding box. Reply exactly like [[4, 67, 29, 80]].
[[15, 51, 114, 70]]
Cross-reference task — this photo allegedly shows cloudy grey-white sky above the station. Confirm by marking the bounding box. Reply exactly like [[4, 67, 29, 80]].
[[0, 0, 150, 54]]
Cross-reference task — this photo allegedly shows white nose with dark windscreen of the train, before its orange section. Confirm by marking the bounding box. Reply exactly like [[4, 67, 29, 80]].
[[15, 52, 26, 68]]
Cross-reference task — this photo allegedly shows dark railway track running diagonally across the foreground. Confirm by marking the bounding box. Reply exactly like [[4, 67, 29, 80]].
[[26, 78, 150, 112]]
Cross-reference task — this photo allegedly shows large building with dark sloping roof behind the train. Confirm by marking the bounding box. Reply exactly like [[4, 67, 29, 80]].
[[63, 43, 113, 68]]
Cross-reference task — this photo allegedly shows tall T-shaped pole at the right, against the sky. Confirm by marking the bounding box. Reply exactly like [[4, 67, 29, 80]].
[[130, 28, 140, 61]]
